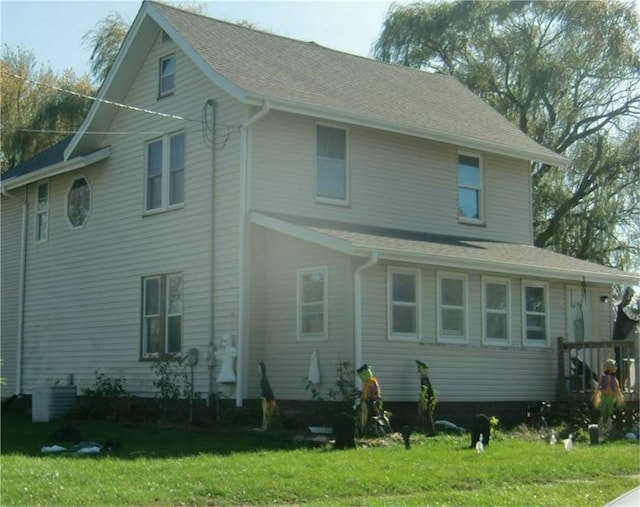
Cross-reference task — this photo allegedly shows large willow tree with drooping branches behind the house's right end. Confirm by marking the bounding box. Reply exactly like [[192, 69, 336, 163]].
[[375, 1, 640, 269]]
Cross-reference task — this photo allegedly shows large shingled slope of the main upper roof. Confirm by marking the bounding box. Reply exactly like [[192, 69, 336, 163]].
[[147, 2, 563, 163]]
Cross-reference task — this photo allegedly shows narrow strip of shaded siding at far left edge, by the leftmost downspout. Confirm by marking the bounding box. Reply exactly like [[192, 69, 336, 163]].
[[0, 191, 24, 398]]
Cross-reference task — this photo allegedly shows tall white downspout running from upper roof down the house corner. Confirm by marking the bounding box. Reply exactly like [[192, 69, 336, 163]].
[[236, 100, 271, 407]]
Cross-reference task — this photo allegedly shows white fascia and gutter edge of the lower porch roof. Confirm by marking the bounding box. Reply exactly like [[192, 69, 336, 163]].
[[249, 212, 640, 285]]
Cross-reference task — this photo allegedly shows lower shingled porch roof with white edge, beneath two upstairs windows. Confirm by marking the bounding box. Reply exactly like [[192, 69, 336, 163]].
[[250, 211, 640, 285]]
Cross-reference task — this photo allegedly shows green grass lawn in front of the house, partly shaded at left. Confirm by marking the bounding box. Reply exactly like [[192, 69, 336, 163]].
[[0, 412, 640, 507]]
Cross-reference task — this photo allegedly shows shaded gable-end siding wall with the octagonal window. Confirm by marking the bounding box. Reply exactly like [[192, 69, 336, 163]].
[[15, 29, 245, 394]]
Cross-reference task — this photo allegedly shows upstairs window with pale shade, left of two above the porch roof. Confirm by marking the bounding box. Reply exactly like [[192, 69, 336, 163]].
[[316, 125, 349, 203]]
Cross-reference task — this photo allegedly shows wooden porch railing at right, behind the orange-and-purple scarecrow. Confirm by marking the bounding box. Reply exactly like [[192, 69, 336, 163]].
[[557, 337, 640, 401]]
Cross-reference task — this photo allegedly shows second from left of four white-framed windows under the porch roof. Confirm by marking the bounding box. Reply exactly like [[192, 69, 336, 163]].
[[437, 272, 468, 343]]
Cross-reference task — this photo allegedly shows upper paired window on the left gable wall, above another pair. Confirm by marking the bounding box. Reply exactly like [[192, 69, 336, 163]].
[[145, 132, 185, 211]]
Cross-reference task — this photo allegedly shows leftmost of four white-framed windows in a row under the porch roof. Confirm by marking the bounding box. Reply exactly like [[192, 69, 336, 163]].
[[387, 266, 420, 341]]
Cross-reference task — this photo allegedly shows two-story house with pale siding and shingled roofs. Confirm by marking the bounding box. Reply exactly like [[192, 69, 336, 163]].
[[1, 1, 639, 424]]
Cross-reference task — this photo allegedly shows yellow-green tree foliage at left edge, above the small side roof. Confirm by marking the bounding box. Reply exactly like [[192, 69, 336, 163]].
[[0, 45, 93, 172]]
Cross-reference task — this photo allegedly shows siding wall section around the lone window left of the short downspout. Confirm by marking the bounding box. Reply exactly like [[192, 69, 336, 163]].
[[248, 227, 353, 400]]
